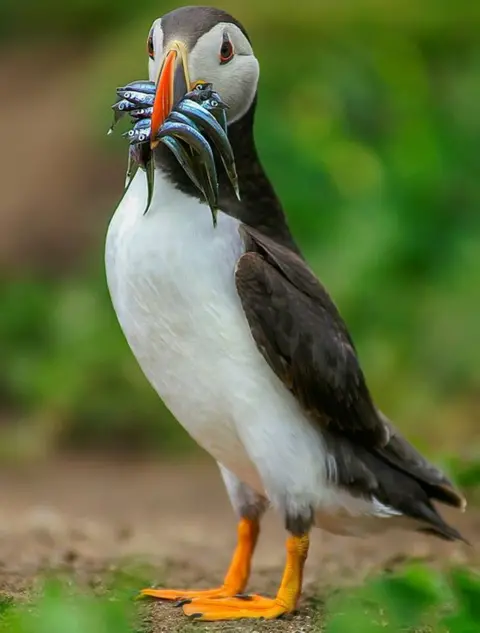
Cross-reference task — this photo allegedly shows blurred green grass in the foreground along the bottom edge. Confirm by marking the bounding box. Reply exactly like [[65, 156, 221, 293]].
[[0, 565, 480, 633]]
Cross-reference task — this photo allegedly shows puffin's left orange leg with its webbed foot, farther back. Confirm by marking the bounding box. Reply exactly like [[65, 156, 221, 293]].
[[141, 519, 260, 600]]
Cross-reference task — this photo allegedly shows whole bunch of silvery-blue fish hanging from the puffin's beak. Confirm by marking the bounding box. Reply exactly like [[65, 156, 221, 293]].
[[109, 81, 240, 226]]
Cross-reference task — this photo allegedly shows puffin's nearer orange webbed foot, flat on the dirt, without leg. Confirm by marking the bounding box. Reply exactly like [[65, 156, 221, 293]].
[[183, 595, 293, 622]]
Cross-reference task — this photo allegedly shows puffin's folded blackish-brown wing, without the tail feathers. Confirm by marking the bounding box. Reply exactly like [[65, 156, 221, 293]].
[[235, 226, 389, 447]]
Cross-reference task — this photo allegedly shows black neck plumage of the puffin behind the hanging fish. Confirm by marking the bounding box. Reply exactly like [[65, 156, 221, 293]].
[[155, 97, 298, 252]]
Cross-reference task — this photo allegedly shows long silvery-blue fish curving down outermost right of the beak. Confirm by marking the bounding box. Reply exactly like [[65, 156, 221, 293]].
[[176, 99, 240, 200]]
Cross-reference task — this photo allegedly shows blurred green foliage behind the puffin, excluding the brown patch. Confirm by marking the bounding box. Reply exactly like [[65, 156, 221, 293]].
[[0, 0, 480, 449]]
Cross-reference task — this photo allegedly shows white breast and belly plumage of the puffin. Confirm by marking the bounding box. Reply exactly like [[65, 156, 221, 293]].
[[106, 171, 404, 523]]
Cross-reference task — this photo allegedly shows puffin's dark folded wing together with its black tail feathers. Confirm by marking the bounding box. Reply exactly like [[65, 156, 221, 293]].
[[236, 226, 465, 540]]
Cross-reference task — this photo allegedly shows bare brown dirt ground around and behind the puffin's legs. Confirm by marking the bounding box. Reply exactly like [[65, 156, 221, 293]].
[[0, 458, 480, 633]]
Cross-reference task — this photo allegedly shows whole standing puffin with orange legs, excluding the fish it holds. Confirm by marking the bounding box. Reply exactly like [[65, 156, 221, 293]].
[[105, 6, 466, 621]]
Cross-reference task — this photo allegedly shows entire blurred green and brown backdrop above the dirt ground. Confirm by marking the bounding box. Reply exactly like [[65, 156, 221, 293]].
[[0, 0, 480, 459]]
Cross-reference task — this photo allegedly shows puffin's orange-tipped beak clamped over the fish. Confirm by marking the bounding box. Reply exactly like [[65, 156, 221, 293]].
[[150, 40, 192, 149]]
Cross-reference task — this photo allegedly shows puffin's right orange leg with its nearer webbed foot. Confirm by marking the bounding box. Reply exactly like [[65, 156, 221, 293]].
[[183, 535, 309, 621]]
